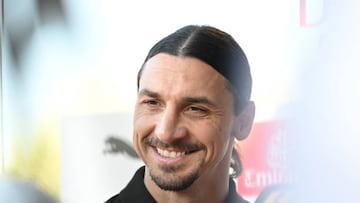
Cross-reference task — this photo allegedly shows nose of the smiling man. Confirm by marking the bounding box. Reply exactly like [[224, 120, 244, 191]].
[[155, 108, 186, 144]]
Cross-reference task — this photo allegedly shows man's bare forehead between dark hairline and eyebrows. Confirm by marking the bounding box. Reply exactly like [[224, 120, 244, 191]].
[[139, 53, 231, 104]]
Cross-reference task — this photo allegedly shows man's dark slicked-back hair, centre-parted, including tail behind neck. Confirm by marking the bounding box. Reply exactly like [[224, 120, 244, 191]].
[[137, 25, 252, 177]]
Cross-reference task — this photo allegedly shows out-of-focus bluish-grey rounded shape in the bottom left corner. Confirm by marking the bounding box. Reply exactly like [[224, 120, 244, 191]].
[[0, 176, 57, 203]]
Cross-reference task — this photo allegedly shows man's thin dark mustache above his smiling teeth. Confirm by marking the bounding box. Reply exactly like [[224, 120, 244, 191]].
[[143, 137, 205, 152]]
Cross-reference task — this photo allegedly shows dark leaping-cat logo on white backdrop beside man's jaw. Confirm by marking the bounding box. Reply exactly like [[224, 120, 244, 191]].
[[104, 135, 139, 159]]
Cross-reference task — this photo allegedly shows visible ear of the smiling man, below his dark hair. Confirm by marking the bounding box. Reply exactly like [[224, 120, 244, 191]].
[[234, 101, 255, 140]]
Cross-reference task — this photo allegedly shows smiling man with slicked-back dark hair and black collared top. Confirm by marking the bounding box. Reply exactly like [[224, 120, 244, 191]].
[[107, 25, 255, 203]]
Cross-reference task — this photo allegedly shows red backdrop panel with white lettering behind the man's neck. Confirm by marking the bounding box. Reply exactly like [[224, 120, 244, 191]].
[[235, 122, 292, 196]]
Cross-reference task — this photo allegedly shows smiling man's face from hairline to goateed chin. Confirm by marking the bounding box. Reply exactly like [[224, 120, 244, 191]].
[[133, 54, 235, 191]]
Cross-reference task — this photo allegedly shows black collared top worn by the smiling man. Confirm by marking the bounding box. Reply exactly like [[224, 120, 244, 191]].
[[105, 166, 248, 203]]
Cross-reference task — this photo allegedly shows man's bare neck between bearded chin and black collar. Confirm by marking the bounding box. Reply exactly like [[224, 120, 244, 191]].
[[144, 154, 230, 203]]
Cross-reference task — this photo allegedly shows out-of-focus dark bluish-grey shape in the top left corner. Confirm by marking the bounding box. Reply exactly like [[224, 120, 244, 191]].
[[4, 0, 67, 68]]
